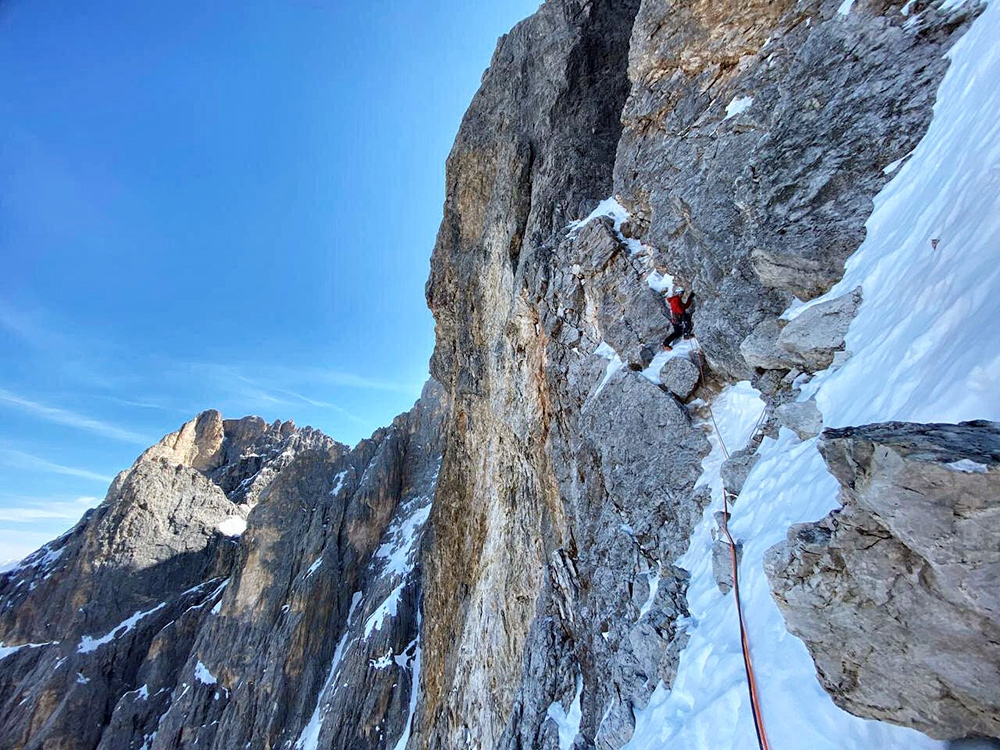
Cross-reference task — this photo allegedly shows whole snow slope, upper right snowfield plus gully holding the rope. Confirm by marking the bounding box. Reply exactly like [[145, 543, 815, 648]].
[[627, 3, 1000, 750]]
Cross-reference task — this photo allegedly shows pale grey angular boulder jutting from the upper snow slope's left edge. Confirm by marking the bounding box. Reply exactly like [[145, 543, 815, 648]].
[[778, 287, 861, 372]]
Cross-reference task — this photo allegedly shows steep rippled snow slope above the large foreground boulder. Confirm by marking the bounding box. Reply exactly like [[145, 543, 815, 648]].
[[809, 3, 1000, 427]]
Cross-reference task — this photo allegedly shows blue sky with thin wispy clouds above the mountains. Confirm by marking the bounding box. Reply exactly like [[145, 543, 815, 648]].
[[0, 0, 538, 562]]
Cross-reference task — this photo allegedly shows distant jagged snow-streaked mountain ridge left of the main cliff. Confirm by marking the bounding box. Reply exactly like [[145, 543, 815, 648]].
[[0, 383, 446, 750]]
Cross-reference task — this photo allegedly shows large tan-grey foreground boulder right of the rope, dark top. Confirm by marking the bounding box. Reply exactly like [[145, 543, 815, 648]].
[[765, 422, 1000, 739]]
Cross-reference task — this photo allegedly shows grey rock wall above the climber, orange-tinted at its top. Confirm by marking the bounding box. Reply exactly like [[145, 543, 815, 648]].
[[615, 0, 968, 378]]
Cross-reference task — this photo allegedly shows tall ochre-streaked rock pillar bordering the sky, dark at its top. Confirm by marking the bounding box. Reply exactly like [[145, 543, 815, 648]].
[[420, 0, 638, 748]]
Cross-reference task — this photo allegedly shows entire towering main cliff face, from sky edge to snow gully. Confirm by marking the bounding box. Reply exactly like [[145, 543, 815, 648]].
[[414, 0, 970, 748]]
